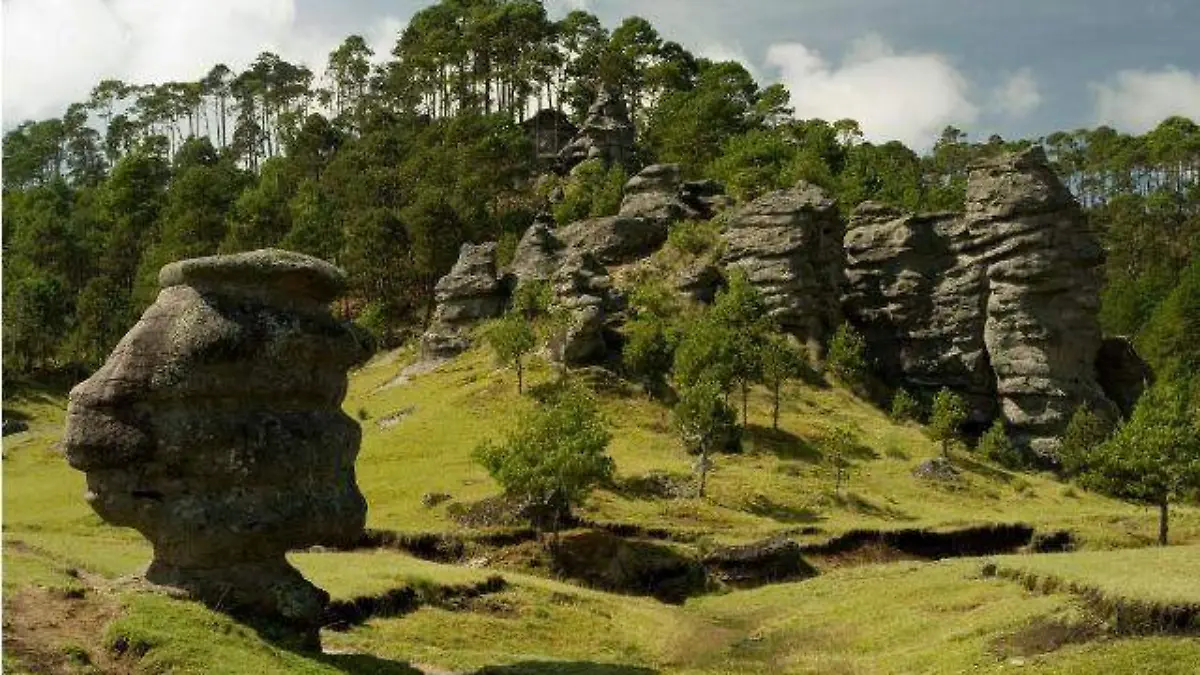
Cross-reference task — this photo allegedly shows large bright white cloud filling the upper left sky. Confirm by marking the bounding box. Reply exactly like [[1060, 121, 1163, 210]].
[[4, 0, 400, 127]]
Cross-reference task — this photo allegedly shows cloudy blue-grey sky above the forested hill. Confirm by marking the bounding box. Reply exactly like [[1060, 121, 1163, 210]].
[[0, 0, 1200, 148]]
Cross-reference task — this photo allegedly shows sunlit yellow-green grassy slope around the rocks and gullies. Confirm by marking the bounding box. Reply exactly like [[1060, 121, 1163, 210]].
[[4, 353, 1200, 675]]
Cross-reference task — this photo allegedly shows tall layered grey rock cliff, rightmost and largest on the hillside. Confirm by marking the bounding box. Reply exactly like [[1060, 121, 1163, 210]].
[[845, 149, 1112, 458]]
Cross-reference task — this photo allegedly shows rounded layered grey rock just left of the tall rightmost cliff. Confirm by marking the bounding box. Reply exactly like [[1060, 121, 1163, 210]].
[[721, 183, 844, 359]]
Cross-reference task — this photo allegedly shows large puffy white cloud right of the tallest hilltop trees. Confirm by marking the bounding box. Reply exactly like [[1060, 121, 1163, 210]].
[[767, 34, 978, 149]]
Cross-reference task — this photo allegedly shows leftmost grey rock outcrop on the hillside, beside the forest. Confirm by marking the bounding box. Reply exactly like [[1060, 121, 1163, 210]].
[[421, 241, 508, 358]]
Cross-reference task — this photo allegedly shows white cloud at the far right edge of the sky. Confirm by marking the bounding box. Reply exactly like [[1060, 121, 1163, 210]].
[[1091, 66, 1200, 133]]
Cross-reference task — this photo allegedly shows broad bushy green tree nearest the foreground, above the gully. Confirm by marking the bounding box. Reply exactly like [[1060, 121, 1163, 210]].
[[474, 387, 614, 531]]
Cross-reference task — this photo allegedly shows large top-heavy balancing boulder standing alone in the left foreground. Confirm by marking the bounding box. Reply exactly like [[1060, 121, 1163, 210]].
[[65, 250, 366, 635]]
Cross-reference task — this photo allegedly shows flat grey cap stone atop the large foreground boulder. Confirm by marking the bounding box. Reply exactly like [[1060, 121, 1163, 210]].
[[158, 249, 346, 303]]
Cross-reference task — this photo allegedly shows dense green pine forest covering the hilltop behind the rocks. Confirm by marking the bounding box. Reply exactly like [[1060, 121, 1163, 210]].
[[4, 0, 1200, 380]]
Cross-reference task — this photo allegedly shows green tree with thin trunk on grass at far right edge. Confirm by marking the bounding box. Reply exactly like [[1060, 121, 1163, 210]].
[[1080, 382, 1200, 545]]
